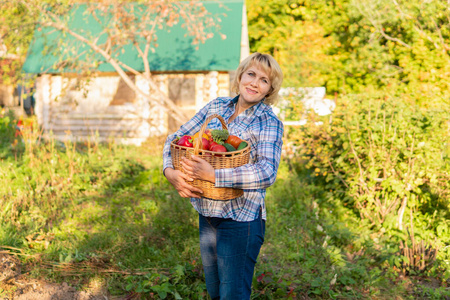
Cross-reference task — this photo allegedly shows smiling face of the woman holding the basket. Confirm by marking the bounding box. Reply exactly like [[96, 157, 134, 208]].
[[239, 65, 272, 108]]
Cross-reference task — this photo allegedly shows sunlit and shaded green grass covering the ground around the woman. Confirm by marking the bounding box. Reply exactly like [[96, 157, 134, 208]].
[[0, 116, 450, 299]]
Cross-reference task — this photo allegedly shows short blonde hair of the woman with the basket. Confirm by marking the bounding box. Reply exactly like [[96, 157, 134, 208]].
[[231, 52, 283, 105]]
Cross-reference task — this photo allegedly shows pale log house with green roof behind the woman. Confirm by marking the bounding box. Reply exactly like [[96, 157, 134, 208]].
[[23, 0, 249, 145]]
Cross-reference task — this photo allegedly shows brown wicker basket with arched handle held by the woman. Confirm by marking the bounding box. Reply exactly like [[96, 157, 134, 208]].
[[170, 114, 250, 200]]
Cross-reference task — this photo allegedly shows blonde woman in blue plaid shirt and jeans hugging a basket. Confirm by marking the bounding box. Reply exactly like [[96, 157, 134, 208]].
[[163, 53, 283, 300]]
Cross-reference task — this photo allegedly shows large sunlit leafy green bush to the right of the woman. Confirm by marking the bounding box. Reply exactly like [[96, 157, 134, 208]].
[[289, 95, 450, 229]]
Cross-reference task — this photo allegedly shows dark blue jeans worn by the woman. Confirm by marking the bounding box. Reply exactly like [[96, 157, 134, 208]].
[[199, 212, 266, 300]]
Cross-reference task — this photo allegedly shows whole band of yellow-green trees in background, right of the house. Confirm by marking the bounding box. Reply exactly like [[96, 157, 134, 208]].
[[248, 0, 450, 106]]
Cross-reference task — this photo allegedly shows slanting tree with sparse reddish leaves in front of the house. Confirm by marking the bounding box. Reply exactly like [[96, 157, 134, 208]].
[[2, 0, 218, 121]]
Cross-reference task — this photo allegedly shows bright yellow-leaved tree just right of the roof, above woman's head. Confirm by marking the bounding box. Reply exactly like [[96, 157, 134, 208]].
[[248, 0, 332, 86]]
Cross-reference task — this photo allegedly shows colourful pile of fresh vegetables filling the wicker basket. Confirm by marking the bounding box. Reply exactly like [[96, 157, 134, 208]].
[[176, 129, 248, 152]]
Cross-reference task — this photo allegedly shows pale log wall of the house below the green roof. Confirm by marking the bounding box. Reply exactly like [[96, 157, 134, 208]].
[[35, 72, 230, 144]]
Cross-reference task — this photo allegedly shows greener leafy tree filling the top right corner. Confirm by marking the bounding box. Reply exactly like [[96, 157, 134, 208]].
[[352, 0, 450, 105]]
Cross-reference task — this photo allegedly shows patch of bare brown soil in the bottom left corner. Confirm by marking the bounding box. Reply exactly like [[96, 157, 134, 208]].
[[0, 252, 112, 300]]
